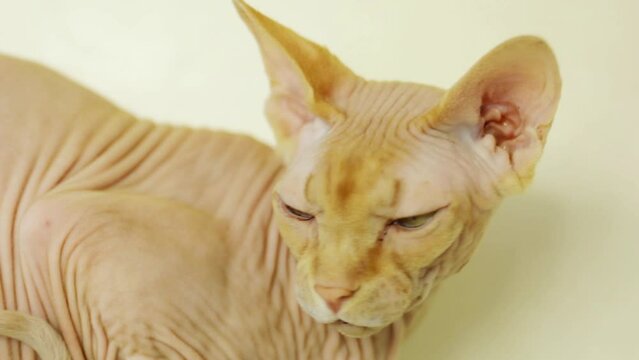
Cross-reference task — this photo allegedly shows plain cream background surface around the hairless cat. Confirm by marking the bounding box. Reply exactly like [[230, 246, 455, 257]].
[[0, 0, 639, 360]]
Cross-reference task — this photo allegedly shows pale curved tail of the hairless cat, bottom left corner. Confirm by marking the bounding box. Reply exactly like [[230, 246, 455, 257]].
[[0, 310, 71, 360]]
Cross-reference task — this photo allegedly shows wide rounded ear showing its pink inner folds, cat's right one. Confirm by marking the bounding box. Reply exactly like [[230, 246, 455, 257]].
[[429, 36, 561, 193]]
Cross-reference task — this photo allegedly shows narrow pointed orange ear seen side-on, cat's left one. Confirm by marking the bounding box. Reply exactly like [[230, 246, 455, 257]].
[[234, 0, 357, 158]]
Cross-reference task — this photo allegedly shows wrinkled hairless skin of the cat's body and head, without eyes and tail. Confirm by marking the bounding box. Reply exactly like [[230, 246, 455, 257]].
[[0, 1, 560, 359]]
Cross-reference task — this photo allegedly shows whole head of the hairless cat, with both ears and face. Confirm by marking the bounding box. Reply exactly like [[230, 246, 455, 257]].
[[235, 0, 561, 337]]
